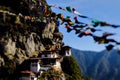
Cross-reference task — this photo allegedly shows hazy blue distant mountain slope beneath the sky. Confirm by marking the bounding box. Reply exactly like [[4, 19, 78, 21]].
[[72, 49, 120, 80]]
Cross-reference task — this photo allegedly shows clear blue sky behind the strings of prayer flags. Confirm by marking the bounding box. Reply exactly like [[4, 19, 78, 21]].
[[46, 0, 120, 52]]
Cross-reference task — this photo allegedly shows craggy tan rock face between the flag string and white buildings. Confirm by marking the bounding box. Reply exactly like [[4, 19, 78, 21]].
[[0, 0, 63, 65]]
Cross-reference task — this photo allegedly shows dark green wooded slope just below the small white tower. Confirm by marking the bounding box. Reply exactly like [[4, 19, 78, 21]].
[[61, 56, 88, 80]]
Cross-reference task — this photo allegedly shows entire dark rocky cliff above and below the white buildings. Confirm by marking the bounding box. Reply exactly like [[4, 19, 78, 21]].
[[0, 0, 88, 80]]
